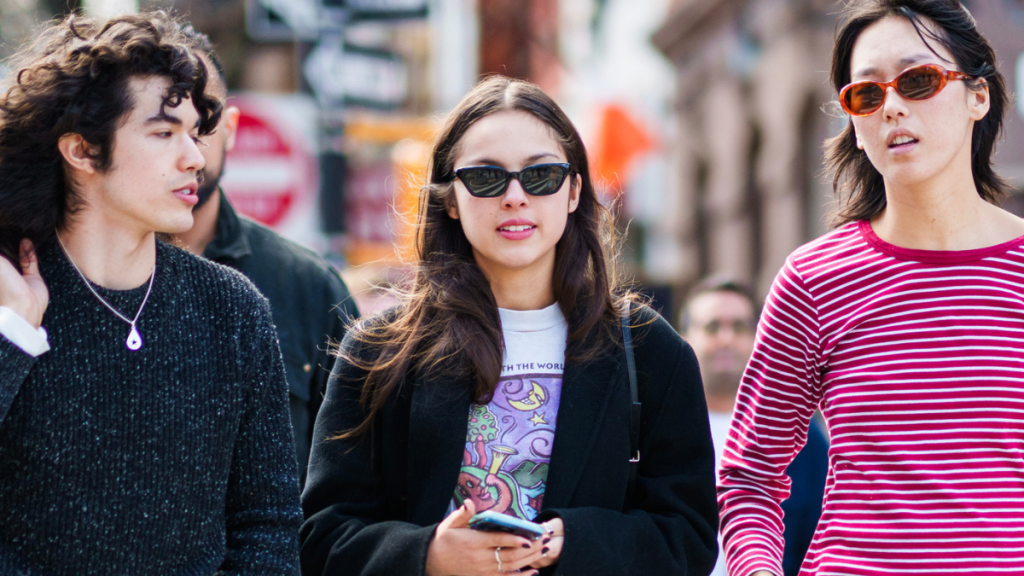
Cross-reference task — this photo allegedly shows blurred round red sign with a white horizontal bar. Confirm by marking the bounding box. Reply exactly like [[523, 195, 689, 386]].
[[221, 97, 315, 228]]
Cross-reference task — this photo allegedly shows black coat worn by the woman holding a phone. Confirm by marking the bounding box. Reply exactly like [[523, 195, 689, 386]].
[[300, 308, 718, 576]]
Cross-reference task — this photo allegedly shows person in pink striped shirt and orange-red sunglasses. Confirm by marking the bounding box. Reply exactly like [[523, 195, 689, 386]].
[[719, 0, 1024, 576]]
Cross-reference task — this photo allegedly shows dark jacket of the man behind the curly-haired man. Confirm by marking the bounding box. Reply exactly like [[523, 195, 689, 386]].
[[203, 191, 359, 481]]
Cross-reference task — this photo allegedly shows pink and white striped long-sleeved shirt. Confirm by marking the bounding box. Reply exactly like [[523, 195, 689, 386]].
[[718, 221, 1024, 576]]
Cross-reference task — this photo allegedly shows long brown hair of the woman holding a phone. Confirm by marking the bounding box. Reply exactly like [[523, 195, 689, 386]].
[[337, 76, 635, 438]]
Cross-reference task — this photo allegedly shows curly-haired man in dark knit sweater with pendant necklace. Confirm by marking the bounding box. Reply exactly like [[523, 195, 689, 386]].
[[0, 12, 301, 575]]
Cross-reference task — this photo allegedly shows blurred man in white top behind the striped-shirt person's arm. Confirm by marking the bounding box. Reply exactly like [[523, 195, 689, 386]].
[[679, 277, 828, 576]]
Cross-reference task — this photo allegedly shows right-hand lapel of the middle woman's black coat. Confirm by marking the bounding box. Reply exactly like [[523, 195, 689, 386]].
[[543, 346, 626, 509]]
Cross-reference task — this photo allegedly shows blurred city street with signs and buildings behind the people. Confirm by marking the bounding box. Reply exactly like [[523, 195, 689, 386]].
[[0, 0, 1024, 319]]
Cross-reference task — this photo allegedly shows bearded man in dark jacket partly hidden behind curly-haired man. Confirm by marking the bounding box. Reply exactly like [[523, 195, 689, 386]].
[[177, 26, 359, 483]]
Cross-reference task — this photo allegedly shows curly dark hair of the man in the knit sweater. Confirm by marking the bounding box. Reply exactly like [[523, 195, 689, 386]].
[[0, 11, 220, 265]]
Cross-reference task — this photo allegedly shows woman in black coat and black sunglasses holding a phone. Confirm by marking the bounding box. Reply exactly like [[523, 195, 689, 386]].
[[301, 77, 717, 576]]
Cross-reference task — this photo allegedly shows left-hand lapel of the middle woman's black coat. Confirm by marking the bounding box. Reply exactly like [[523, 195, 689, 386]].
[[407, 378, 472, 526]]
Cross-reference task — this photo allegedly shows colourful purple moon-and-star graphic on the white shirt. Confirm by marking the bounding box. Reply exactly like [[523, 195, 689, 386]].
[[453, 365, 562, 520]]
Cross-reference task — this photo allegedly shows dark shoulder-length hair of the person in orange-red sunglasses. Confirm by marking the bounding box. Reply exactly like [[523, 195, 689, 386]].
[[824, 0, 1009, 225]]
